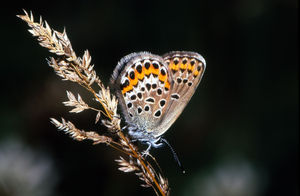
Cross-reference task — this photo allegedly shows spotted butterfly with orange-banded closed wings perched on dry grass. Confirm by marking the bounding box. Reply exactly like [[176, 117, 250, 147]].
[[111, 51, 206, 156]]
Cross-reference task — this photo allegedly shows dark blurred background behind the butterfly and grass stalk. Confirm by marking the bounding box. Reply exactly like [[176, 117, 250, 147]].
[[0, 0, 299, 196]]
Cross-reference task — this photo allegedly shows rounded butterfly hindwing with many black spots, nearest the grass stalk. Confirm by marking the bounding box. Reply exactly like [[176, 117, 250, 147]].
[[111, 52, 174, 133]]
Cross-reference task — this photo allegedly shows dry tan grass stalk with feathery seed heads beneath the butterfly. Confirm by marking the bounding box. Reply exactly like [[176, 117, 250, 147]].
[[17, 10, 169, 196]]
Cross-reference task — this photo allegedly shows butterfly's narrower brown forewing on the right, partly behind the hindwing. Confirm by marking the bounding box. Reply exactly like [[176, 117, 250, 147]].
[[153, 51, 206, 137]]
